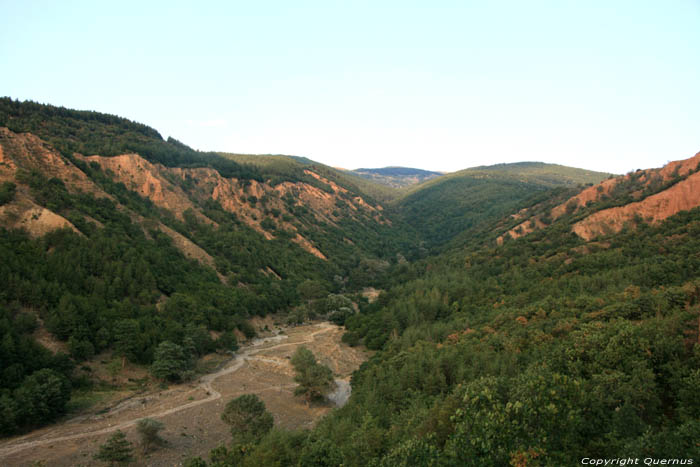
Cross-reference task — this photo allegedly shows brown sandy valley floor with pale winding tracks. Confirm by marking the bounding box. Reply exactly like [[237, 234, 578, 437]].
[[0, 323, 366, 466]]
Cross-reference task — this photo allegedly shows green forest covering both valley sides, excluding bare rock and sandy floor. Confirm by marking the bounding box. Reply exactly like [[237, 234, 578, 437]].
[[0, 99, 700, 466]]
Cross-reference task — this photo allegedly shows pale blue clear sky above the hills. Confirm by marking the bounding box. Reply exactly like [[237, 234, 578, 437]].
[[0, 0, 700, 173]]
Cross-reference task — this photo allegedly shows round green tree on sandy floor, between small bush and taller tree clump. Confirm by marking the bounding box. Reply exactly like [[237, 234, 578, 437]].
[[221, 394, 274, 443]]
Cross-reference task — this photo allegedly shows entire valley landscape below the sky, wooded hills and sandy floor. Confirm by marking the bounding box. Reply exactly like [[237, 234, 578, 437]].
[[0, 98, 700, 467]]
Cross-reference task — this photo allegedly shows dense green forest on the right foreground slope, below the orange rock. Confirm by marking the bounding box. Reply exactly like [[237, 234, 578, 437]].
[[213, 209, 700, 466]]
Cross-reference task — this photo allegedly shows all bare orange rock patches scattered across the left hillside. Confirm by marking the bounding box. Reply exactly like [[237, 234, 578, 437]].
[[0, 128, 389, 267]]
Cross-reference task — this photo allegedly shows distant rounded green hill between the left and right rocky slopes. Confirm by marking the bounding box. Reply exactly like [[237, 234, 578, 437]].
[[393, 162, 609, 248]]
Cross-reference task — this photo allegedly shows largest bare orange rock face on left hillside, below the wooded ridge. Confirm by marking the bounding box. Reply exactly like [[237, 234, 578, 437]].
[[79, 154, 388, 260]]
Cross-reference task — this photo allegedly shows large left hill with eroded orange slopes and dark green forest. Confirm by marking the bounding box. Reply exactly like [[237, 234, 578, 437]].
[[0, 99, 409, 434]]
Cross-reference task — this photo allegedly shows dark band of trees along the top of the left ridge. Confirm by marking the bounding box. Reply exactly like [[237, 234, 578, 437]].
[[0, 97, 394, 200]]
